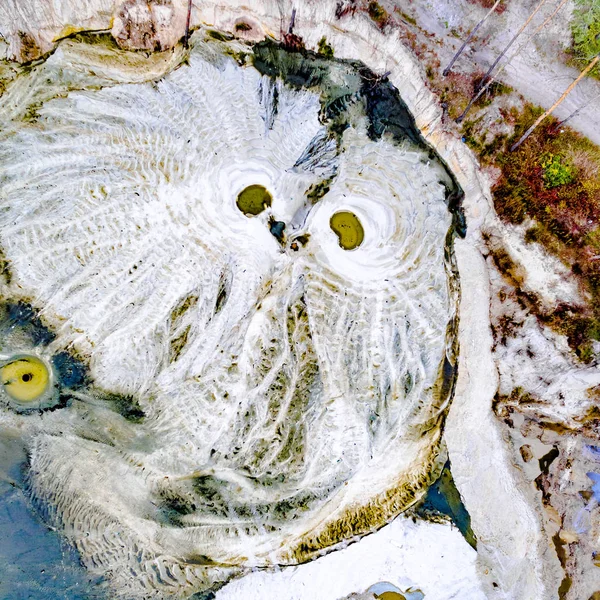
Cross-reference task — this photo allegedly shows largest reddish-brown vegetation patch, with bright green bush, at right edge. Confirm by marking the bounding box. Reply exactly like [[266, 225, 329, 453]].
[[492, 105, 600, 362]]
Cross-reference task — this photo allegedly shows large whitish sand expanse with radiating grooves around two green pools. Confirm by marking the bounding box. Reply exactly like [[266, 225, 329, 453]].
[[0, 38, 457, 598]]
